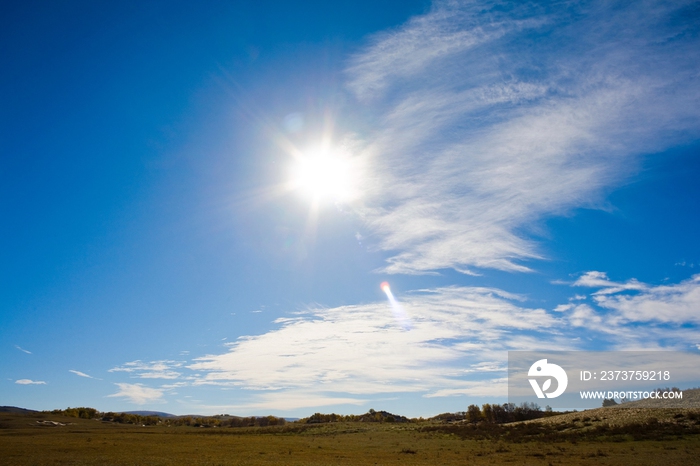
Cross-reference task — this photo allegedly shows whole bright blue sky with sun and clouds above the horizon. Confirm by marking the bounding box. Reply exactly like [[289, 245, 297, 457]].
[[0, 1, 700, 416]]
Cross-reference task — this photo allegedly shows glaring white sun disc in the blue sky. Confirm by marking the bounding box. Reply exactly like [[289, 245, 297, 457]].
[[291, 147, 357, 202]]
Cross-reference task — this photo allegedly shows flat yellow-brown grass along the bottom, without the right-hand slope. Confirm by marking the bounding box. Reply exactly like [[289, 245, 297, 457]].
[[0, 412, 700, 466]]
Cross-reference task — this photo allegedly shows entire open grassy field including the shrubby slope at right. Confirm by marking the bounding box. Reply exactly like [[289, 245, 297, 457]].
[[0, 409, 700, 465]]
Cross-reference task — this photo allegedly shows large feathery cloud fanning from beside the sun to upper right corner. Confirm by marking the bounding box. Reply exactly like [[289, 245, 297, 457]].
[[347, 1, 700, 274]]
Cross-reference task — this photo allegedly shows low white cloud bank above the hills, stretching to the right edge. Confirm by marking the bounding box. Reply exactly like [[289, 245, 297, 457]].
[[187, 272, 700, 409]]
